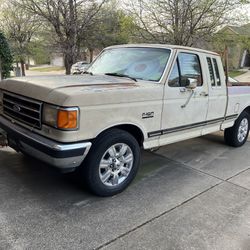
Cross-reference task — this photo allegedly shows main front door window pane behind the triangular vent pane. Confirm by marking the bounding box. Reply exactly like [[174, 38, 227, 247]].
[[178, 53, 203, 86]]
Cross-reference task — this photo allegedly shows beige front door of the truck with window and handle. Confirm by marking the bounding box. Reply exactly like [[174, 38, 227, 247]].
[[160, 50, 208, 145]]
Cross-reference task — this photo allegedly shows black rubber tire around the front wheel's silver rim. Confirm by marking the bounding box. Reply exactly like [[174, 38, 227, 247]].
[[80, 129, 140, 197]]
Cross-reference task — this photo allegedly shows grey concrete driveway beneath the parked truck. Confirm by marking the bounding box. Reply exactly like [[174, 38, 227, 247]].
[[0, 134, 250, 250]]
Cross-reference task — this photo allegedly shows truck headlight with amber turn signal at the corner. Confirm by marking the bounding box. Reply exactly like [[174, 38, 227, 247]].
[[43, 104, 79, 130]]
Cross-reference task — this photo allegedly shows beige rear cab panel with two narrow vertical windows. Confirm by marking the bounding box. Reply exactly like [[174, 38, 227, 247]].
[[202, 55, 227, 134]]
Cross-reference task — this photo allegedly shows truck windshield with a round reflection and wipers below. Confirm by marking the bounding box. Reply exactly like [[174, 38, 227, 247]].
[[88, 48, 170, 81]]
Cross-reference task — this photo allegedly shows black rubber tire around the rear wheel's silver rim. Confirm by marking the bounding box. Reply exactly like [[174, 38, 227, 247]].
[[224, 111, 250, 147]]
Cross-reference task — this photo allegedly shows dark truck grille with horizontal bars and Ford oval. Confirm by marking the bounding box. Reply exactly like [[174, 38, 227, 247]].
[[3, 92, 42, 129]]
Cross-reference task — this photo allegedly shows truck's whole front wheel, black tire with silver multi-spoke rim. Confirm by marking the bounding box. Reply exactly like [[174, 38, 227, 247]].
[[81, 129, 140, 196]]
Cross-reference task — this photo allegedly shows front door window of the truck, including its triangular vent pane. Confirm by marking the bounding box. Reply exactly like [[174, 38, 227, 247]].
[[168, 53, 203, 87]]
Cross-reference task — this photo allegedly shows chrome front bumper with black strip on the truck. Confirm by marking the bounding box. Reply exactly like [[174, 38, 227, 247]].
[[0, 116, 92, 170]]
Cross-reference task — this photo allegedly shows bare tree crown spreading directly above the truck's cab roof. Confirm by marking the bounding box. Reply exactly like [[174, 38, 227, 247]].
[[128, 0, 249, 46]]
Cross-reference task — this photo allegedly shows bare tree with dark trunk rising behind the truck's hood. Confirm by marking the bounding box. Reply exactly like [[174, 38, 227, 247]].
[[18, 0, 107, 74]]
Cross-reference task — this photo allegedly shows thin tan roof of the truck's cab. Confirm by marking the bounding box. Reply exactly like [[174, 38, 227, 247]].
[[108, 43, 219, 55]]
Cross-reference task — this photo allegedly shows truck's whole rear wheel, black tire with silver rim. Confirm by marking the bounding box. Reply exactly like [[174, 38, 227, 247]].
[[224, 111, 250, 147]]
